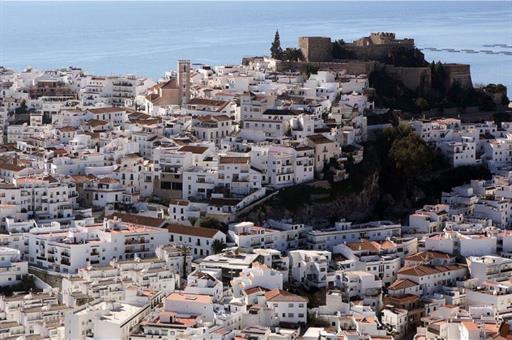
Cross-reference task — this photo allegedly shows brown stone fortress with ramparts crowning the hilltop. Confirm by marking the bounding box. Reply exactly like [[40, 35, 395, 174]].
[[284, 32, 472, 90]]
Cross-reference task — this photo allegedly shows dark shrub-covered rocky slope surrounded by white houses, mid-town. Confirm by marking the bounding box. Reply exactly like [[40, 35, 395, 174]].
[[243, 127, 490, 227]]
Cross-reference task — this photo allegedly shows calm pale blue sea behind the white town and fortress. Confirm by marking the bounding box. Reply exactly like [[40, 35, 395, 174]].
[[0, 0, 512, 88]]
